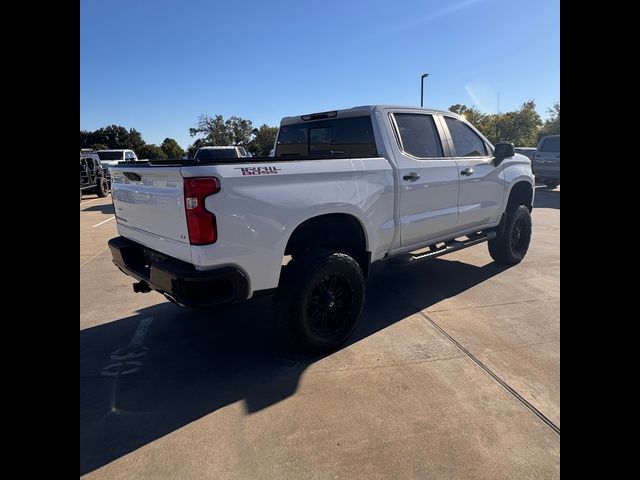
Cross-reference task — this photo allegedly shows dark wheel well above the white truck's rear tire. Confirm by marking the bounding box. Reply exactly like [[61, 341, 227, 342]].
[[284, 213, 371, 276]]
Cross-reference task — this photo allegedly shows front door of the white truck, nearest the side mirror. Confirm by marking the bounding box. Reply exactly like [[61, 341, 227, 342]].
[[439, 115, 505, 231]]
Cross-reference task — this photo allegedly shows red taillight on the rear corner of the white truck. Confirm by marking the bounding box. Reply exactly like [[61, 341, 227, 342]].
[[184, 177, 220, 245]]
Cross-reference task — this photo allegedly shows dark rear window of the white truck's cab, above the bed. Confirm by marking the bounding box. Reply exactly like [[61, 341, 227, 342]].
[[275, 116, 378, 157]]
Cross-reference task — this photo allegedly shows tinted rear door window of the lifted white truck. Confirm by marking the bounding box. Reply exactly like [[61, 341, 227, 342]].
[[394, 113, 442, 158]]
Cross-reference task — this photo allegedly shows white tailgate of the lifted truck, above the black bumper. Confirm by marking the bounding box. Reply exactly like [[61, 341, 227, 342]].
[[111, 165, 191, 261]]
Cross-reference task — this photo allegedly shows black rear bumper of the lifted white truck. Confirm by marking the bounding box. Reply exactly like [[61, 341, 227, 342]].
[[109, 237, 249, 307]]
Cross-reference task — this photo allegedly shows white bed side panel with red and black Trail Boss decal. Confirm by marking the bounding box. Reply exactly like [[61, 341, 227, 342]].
[[181, 157, 394, 293]]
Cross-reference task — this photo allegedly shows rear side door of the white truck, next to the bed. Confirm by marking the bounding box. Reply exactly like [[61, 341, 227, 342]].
[[388, 111, 458, 247]]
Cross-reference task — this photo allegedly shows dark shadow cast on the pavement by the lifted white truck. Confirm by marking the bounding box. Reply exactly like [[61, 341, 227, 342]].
[[80, 259, 505, 475]]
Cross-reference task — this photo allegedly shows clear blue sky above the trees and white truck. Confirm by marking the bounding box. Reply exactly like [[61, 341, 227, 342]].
[[80, 0, 560, 147]]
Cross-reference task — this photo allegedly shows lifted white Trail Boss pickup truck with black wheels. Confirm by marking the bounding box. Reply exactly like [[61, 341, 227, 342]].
[[109, 105, 534, 353]]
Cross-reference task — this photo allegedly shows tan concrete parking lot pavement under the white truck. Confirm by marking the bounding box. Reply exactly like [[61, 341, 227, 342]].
[[80, 188, 560, 479]]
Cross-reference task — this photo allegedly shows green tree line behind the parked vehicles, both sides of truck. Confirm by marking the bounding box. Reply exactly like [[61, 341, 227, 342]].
[[80, 100, 560, 160]]
